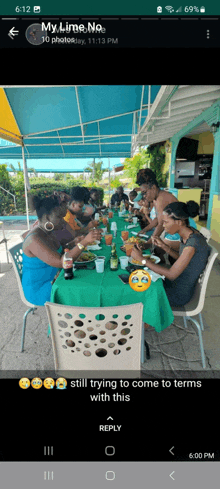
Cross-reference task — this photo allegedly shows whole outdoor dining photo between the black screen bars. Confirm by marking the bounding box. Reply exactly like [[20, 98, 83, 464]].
[[0, 85, 220, 379]]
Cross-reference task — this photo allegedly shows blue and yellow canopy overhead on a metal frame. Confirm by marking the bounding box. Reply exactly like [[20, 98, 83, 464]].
[[0, 85, 160, 159]]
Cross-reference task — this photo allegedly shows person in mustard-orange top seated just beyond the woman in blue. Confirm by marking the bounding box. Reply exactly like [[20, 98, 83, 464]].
[[64, 187, 99, 234]]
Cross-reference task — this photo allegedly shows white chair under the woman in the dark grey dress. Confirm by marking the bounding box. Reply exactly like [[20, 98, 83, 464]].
[[172, 245, 218, 368]]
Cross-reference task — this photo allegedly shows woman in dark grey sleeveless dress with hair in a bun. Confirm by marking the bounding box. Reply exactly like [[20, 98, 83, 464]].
[[131, 201, 210, 307]]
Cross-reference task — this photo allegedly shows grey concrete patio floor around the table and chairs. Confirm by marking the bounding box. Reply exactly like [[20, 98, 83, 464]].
[[0, 229, 220, 378]]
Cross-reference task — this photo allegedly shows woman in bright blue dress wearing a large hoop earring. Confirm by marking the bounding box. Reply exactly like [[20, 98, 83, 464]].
[[22, 195, 101, 306]]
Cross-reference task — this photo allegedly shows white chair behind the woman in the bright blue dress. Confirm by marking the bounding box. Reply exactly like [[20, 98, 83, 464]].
[[8, 242, 37, 352]]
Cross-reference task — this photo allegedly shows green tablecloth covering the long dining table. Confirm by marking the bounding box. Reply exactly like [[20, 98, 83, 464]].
[[51, 213, 174, 332]]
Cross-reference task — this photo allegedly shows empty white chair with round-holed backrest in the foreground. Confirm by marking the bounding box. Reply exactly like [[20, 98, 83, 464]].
[[45, 302, 143, 378]]
